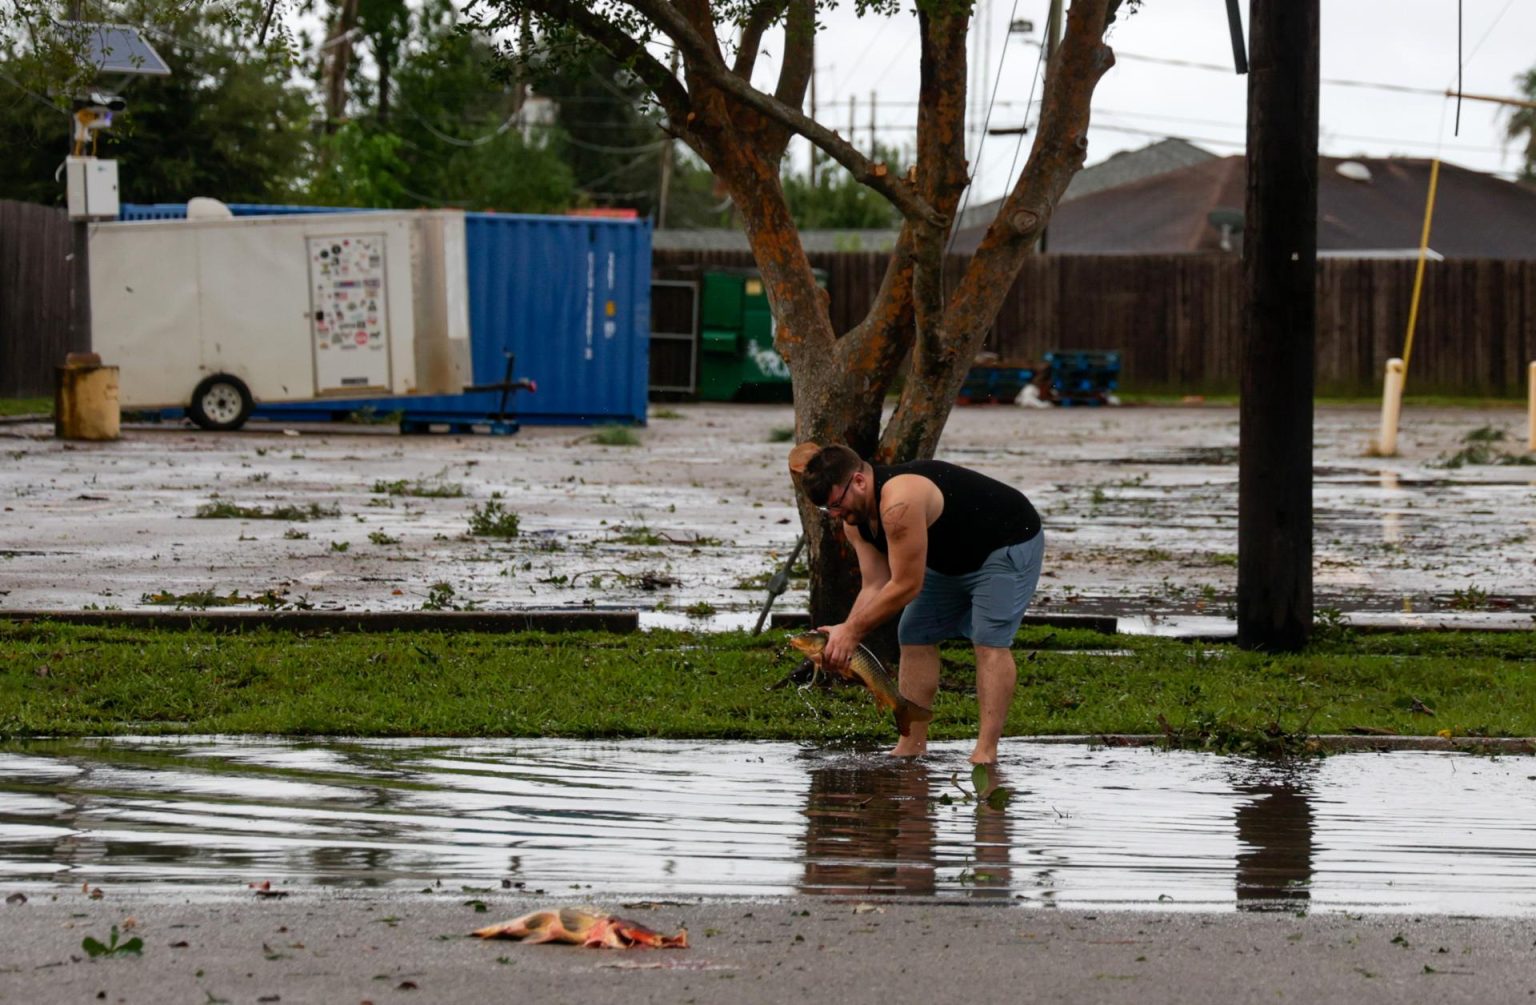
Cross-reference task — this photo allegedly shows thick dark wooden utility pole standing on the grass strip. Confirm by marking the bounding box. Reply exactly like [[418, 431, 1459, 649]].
[[1238, 0, 1319, 652]]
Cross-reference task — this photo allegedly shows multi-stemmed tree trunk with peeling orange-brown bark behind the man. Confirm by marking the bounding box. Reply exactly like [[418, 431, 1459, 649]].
[[463, 0, 1121, 624]]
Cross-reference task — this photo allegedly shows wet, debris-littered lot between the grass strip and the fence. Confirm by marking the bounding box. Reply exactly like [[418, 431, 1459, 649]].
[[0, 404, 1536, 630]]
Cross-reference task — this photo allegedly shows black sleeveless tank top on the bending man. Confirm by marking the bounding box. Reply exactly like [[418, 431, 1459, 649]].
[[859, 461, 1040, 576]]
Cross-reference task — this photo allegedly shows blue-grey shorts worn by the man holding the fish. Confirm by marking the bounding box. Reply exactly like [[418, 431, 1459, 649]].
[[895, 530, 1046, 648]]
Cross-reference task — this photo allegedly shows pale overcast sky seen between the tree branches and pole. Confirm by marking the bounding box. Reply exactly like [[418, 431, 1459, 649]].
[[756, 0, 1536, 200]]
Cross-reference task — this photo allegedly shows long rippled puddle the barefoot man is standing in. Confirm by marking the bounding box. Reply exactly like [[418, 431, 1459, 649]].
[[0, 738, 1536, 916]]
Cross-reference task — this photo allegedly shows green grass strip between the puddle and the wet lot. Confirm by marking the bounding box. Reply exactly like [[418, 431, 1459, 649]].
[[0, 621, 1536, 751]]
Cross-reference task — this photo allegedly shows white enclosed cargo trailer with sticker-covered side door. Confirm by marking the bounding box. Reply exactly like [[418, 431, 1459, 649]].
[[91, 211, 470, 429]]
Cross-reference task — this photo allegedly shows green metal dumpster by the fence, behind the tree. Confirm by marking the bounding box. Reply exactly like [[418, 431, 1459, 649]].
[[699, 269, 825, 401]]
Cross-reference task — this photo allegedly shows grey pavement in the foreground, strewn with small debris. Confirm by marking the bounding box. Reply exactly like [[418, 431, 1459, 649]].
[[0, 888, 1536, 1005]]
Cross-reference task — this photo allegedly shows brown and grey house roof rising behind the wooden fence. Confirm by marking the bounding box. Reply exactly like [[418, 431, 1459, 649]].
[[955, 155, 1536, 258]]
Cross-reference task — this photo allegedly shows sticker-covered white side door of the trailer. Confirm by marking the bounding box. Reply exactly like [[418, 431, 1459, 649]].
[[306, 234, 390, 393]]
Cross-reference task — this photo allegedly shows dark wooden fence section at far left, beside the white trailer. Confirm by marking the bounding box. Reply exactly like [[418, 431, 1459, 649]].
[[0, 200, 72, 398]]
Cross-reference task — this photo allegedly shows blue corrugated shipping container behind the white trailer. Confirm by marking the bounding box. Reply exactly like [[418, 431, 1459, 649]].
[[121, 203, 651, 424]]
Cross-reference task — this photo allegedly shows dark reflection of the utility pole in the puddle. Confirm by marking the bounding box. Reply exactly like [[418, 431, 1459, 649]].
[[1233, 768, 1312, 911]]
